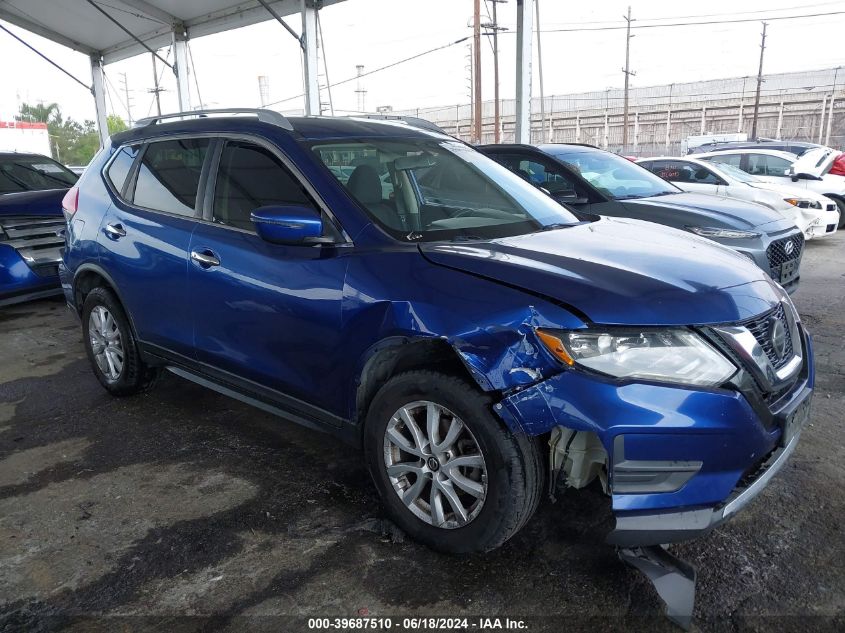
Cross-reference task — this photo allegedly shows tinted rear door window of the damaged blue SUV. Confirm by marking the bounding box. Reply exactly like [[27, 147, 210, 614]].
[[133, 139, 209, 216]]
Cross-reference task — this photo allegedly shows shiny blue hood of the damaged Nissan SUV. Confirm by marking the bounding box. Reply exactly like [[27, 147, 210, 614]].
[[420, 218, 778, 325]]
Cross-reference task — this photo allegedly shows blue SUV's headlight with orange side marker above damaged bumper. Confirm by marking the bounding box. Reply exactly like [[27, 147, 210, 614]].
[[537, 328, 736, 387]]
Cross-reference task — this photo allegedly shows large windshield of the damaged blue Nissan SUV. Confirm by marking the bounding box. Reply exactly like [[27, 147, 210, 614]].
[[312, 138, 579, 241]]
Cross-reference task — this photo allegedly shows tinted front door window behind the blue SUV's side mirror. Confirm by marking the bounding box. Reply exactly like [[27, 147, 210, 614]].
[[213, 141, 314, 231]]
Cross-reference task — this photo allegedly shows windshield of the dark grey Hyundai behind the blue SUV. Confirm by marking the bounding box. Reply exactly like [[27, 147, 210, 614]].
[[549, 150, 681, 200]]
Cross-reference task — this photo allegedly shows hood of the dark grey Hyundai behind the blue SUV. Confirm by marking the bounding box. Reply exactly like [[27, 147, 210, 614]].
[[620, 192, 784, 230]]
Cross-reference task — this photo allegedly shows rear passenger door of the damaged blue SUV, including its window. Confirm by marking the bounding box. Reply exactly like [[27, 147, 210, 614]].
[[97, 138, 211, 356]]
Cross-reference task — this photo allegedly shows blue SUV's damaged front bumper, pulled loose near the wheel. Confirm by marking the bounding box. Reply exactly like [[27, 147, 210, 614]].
[[495, 330, 814, 547]]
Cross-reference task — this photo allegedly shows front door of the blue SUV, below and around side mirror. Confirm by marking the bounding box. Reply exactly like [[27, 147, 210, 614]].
[[188, 139, 348, 416]]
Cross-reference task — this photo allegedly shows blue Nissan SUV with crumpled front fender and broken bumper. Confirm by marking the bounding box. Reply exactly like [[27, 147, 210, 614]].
[[60, 111, 813, 552]]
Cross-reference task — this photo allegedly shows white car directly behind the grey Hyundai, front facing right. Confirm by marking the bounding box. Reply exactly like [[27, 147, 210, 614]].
[[637, 156, 840, 240]]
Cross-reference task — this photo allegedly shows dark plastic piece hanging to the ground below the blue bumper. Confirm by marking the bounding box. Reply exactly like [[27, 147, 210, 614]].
[[617, 545, 695, 631]]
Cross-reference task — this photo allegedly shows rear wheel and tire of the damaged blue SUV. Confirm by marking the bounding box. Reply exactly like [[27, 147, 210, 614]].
[[82, 288, 160, 396]]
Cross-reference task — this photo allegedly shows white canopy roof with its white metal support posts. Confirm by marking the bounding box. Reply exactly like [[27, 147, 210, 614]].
[[0, 0, 534, 142]]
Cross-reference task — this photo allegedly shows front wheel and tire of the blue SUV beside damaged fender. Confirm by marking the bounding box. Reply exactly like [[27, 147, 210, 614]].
[[364, 371, 544, 554]]
